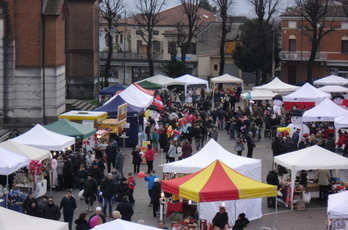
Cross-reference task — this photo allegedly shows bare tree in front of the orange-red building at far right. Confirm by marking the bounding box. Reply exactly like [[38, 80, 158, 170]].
[[296, 0, 338, 83]]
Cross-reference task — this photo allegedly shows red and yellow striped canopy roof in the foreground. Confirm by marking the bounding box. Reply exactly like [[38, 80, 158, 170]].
[[162, 160, 277, 202]]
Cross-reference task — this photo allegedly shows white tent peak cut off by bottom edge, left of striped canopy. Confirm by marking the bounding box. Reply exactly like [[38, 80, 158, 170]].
[[93, 219, 158, 230]]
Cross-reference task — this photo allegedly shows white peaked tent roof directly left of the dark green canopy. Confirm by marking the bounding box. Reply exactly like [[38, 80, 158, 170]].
[[11, 124, 75, 151]]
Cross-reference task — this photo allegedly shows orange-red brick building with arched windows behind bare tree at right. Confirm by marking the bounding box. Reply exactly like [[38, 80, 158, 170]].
[[279, 3, 348, 84]]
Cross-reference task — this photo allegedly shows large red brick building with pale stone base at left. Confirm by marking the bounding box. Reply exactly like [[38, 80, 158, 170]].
[[0, 0, 98, 125]]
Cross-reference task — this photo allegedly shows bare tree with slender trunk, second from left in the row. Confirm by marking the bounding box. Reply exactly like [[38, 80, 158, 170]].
[[133, 0, 165, 77]]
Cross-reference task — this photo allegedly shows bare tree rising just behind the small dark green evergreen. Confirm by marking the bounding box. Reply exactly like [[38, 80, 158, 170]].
[[177, 0, 204, 63]]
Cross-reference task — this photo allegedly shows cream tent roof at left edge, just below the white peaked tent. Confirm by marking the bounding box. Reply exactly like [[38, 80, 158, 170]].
[[0, 140, 50, 161]]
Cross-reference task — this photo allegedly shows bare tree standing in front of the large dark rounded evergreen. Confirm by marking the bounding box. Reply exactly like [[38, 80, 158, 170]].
[[250, 0, 279, 85]]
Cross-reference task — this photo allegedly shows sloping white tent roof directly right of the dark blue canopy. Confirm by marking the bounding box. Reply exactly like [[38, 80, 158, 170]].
[[118, 85, 153, 108]]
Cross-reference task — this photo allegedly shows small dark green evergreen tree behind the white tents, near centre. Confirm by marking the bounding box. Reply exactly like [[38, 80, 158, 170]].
[[163, 50, 188, 78]]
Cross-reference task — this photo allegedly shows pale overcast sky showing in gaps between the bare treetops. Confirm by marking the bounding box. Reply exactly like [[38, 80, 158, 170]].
[[125, 0, 293, 18]]
